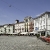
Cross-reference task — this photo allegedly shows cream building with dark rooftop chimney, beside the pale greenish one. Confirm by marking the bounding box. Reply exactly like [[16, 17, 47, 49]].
[[15, 20, 25, 34]]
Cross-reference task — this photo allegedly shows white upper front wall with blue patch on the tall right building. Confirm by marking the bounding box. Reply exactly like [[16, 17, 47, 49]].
[[34, 14, 47, 31]]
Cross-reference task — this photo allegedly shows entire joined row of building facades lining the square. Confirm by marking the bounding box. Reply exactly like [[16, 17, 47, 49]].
[[0, 12, 50, 36]]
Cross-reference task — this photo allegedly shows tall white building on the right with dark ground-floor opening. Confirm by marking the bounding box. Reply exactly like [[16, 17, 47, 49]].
[[34, 12, 50, 35]]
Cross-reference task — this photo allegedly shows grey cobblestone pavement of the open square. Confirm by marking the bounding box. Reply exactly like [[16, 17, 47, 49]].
[[0, 36, 50, 50]]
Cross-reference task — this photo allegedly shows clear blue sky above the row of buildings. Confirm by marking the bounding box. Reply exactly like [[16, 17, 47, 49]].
[[0, 0, 50, 25]]
